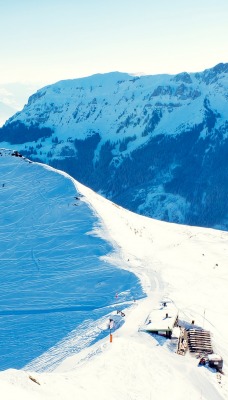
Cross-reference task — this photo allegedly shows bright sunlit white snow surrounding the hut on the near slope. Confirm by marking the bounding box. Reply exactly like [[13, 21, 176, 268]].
[[0, 151, 228, 400]]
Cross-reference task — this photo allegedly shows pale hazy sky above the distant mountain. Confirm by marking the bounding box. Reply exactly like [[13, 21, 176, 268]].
[[0, 0, 228, 84]]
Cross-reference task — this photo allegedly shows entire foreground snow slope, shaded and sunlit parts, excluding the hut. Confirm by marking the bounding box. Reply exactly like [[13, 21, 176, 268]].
[[0, 150, 228, 400]]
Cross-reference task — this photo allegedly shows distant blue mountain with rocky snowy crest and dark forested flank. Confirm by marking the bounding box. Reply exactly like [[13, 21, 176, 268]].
[[0, 64, 228, 230]]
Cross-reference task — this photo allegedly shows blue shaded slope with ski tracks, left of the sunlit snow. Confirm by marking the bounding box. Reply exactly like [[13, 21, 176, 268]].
[[0, 149, 143, 370]]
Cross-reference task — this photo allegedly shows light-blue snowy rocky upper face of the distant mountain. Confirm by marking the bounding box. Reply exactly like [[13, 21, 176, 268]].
[[2, 67, 227, 162]]
